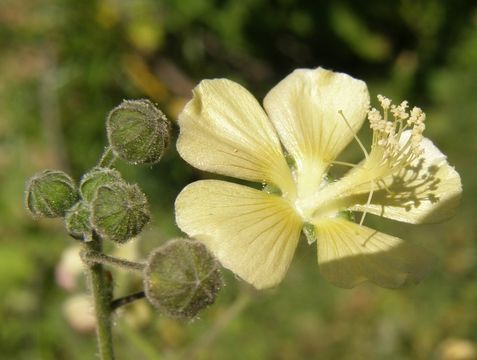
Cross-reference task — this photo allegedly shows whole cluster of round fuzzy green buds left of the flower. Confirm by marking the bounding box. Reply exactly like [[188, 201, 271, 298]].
[[25, 100, 222, 317]]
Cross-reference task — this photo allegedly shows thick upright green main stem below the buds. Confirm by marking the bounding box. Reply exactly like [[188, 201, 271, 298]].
[[84, 236, 114, 360]]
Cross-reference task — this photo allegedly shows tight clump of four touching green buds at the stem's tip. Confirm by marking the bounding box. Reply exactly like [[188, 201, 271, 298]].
[[25, 167, 150, 243]]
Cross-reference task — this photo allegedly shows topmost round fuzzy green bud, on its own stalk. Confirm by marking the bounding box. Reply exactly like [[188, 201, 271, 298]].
[[106, 100, 170, 164]]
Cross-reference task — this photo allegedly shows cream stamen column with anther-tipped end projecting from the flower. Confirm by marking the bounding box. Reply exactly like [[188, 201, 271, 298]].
[[295, 95, 426, 224]]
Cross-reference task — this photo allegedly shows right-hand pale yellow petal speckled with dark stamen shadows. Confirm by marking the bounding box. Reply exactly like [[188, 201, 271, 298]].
[[322, 131, 462, 224]]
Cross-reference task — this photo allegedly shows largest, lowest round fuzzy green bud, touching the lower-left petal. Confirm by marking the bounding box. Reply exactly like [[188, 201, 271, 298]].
[[144, 239, 223, 318]]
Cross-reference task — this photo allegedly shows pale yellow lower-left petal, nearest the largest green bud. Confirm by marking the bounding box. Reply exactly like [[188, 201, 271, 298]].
[[175, 180, 302, 289]]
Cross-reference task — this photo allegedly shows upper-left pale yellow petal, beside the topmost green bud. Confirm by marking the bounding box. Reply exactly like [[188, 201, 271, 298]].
[[177, 79, 294, 197]]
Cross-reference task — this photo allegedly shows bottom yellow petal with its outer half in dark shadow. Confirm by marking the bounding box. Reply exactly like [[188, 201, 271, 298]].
[[315, 219, 434, 288]]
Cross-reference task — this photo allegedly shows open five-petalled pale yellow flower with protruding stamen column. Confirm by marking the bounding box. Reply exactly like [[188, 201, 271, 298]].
[[176, 68, 462, 289]]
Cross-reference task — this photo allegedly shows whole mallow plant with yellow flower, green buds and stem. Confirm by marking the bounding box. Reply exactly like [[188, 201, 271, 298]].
[[25, 68, 462, 359]]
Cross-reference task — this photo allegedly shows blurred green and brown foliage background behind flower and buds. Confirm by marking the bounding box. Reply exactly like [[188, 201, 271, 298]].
[[0, 0, 477, 360]]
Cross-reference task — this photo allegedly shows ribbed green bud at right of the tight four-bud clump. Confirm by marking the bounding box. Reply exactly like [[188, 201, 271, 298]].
[[91, 182, 150, 243]]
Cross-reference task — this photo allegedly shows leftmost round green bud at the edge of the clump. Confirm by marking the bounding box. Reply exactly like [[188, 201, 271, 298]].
[[25, 170, 78, 218]]
